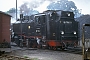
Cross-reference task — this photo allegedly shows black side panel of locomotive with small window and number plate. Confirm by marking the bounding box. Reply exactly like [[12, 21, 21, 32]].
[[34, 13, 46, 37]]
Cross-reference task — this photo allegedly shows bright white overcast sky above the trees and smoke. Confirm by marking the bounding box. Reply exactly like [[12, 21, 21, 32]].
[[0, 0, 90, 14]]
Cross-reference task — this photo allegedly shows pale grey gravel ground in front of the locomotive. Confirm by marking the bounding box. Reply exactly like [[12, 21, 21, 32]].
[[7, 49, 82, 60]]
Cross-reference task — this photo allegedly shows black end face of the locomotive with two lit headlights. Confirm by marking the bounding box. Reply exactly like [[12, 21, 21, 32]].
[[58, 11, 78, 47]]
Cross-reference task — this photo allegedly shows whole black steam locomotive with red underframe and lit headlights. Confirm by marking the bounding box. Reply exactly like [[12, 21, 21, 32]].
[[13, 10, 79, 50]]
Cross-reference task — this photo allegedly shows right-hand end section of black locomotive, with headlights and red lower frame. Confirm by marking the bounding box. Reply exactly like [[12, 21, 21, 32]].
[[45, 10, 78, 50]]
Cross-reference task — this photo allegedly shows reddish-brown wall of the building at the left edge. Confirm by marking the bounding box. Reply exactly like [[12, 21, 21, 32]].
[[0, 13, 11, 43]]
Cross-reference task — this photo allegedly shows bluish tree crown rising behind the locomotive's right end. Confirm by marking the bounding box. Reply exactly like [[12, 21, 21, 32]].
[[47, 0, 79, 17]]
